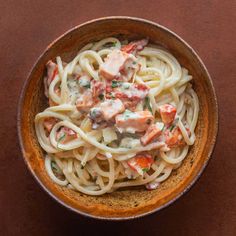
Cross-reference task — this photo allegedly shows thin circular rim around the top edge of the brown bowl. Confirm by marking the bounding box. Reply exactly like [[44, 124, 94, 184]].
[[17, 16, 219, 221]]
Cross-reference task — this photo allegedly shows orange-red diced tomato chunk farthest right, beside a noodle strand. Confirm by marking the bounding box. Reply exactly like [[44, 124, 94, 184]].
[[164, 127, 185, 147]]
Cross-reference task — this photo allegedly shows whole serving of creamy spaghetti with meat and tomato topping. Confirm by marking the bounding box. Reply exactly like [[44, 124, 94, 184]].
[[35, 37, 199, 195]]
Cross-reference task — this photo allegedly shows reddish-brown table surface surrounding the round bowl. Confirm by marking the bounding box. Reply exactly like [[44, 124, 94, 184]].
[[0, 0, 236, 235]]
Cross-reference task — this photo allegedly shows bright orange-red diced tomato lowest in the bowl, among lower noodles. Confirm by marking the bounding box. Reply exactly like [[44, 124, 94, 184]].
[[127, 154, 154, 175]]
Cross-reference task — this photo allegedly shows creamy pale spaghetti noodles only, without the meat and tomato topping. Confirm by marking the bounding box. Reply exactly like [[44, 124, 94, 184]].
[[35, 38, 199, 195]]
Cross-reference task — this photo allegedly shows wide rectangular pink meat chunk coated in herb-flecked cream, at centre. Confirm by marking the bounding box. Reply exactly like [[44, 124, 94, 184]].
[[116, 110, 154, 133]]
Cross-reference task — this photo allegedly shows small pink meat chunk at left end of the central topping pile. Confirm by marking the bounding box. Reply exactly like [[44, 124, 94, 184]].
[[76, 90, 94, 112]]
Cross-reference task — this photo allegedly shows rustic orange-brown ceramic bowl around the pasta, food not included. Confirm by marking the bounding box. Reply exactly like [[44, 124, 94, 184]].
[[18, 17, 218, 220]]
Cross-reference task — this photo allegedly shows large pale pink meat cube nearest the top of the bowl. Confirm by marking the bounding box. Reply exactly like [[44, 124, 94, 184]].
[[99, 49, 135, 80]]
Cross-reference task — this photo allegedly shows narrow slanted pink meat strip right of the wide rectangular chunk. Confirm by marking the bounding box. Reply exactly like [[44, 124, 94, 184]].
[[140, 122, 164, 146]]
